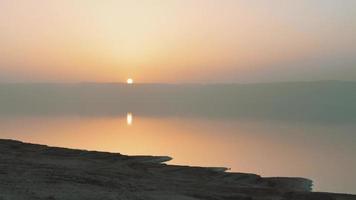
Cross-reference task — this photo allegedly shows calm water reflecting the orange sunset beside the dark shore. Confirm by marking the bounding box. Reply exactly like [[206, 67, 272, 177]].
[[0, 113, 356, 193]]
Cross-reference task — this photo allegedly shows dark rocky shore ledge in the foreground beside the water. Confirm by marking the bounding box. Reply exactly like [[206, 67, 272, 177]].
[[0, 139, 356, 200]]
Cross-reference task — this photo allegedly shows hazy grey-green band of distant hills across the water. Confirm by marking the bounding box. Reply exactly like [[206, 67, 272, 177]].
[[0, 81, 356, 122]]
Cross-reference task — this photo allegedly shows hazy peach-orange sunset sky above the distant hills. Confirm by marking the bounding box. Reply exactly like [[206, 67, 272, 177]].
[[0, 0, 356, 82]]
